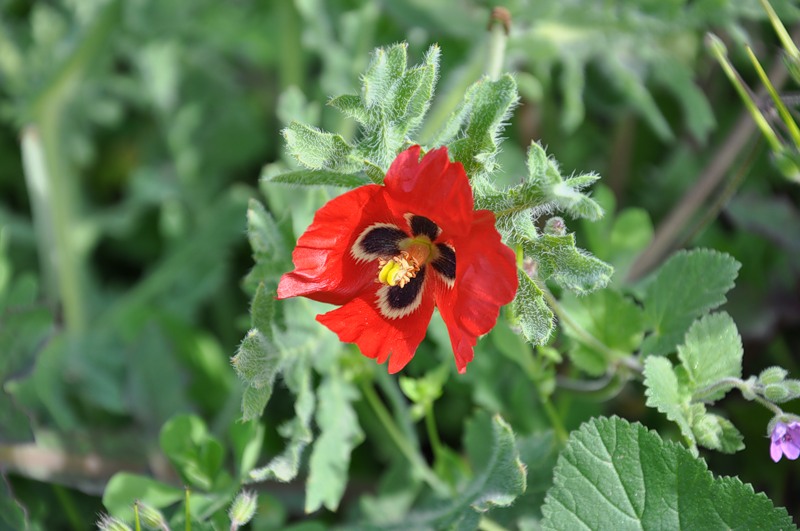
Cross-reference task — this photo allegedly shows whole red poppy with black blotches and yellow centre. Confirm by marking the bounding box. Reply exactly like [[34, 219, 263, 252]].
[[278, 146, 517, 373]]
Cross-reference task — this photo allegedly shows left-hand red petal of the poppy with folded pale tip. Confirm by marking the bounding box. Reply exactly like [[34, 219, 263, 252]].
[[278, 185, 388, 304]]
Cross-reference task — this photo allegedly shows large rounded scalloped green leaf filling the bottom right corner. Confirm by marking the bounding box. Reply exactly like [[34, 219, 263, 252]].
[[542, 418, 796, 531]]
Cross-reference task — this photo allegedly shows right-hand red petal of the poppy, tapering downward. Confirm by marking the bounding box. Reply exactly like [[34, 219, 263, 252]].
[[436, 210, 517, 372]]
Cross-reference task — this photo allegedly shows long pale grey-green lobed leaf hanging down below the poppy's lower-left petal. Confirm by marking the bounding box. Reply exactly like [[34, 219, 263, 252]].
[[305, 374, 364, 513]]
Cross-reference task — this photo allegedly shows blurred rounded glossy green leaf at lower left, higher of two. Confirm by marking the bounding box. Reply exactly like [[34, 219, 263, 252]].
[[159, 415, 225, 490]]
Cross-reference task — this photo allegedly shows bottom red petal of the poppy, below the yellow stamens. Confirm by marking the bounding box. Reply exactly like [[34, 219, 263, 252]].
[[317, 284, 433, 374]]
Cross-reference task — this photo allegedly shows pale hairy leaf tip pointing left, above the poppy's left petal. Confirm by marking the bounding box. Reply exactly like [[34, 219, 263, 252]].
[[283, 122, 361, 174]]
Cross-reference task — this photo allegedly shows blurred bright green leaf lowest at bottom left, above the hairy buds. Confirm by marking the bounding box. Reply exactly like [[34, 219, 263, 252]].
[[103, 472, 184, 522]]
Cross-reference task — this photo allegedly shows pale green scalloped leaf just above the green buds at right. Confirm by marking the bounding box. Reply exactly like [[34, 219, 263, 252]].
[[678, 312, 744, 401]]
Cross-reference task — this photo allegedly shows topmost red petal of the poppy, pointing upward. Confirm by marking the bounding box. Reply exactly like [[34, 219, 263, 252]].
[[384, 146, 474, 240]]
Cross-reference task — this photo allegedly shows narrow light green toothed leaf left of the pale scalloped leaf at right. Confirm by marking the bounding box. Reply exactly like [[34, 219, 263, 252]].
[[644, 356, 695, 444]]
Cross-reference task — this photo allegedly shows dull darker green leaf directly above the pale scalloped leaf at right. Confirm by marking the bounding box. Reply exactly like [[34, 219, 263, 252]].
[[642, 249, 740, 355]]
